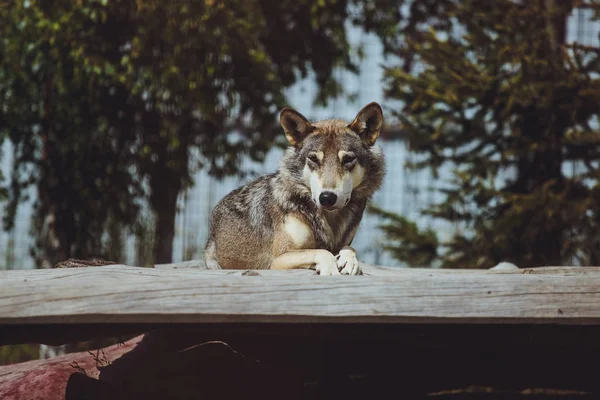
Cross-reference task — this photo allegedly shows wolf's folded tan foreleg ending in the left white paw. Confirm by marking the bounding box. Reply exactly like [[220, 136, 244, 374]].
[[271, 249, 340, 275]]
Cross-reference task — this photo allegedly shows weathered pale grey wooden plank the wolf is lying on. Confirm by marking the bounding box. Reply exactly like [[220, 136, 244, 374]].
[[0, 265, 600, 324]]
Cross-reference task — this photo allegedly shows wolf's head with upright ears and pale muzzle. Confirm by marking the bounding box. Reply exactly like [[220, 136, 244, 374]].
[[280, 103, 383, 211]]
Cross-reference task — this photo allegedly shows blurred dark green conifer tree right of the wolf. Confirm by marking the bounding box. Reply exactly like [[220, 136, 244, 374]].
[[375, 0, 600, 268]]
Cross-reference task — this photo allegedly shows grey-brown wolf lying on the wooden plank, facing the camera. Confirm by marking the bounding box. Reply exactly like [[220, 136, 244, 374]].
[[204, 103, 385, 275]]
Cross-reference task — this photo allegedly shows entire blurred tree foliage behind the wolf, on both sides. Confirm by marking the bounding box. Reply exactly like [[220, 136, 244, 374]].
[[0, 0, 600, 268]]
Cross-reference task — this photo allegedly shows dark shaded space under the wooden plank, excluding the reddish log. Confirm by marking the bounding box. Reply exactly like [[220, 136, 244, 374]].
[[0, 324, 600, 400]]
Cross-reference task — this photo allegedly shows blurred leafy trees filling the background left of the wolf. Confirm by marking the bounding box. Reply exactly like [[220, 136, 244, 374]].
[[0, 0, 404, 266]]
